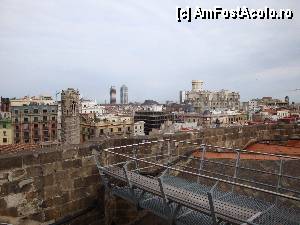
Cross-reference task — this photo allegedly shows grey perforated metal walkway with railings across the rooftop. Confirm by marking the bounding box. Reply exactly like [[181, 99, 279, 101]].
[[92, 140, 300, 225]]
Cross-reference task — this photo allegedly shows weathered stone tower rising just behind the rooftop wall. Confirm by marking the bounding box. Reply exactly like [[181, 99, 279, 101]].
[[61, 88, 80, 144]]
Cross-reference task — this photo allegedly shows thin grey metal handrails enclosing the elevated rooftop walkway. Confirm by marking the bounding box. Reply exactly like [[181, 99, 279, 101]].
[[92, 139, 300, 201]]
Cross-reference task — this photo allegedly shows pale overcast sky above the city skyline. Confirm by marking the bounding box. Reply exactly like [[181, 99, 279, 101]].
[[0, 0, 300, 102]]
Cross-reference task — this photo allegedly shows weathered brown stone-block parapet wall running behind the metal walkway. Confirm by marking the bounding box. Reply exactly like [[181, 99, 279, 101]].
[[0, 125, 300, 225]]
